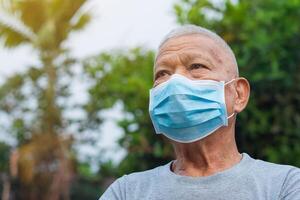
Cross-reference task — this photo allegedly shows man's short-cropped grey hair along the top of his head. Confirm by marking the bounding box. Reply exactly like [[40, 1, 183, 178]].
[[155, 24, 239, 76]]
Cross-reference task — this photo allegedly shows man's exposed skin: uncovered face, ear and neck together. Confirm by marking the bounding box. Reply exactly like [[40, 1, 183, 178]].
[[153, 34, 250, 176]]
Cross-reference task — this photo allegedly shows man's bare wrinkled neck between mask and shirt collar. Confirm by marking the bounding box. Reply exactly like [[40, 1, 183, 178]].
[[171, 130, 242, 177]]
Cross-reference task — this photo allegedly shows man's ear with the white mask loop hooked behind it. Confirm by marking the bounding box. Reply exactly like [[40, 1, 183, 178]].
[[234, 77, 250, 113]]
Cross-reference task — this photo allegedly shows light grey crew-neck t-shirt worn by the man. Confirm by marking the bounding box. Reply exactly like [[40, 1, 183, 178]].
[[100, 153, 300, 200]]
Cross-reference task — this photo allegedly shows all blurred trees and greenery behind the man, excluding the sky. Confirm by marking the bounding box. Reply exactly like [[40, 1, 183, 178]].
[[0, 0, 300, 200]]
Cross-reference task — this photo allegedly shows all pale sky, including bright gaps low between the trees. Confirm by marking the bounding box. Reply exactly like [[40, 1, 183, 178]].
[[0, 0, 176, 164]]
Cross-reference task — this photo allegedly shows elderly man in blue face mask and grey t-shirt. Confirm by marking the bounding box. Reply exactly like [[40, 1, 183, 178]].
[[100, 25, 300, 200]]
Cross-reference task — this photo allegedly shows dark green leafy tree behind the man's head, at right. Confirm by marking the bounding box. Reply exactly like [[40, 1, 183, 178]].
[[174, 0, 300, 166]]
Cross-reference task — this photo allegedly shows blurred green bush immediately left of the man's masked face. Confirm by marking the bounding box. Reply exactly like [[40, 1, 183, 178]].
[[85, 48, 173, 176]]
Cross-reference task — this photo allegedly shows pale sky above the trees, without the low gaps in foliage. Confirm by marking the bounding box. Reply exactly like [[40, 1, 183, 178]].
[[0, 0, 176, 75]]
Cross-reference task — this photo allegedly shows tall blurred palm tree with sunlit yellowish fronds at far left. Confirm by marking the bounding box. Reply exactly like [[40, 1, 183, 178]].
[[0, 0, 90, 200]]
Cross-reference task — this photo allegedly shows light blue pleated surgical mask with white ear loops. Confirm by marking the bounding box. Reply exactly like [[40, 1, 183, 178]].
[[149, 74, 234, 143]]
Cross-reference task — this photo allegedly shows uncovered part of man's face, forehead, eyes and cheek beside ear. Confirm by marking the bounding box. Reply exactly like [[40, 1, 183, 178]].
[[154, 34, 237, 118]]
